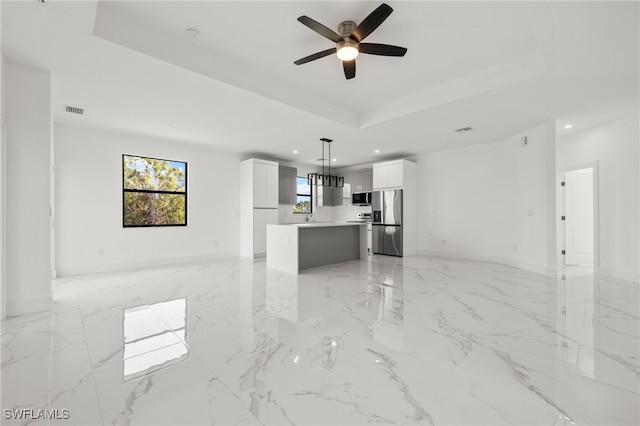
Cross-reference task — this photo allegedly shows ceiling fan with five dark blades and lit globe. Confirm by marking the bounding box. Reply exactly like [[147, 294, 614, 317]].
[[294, 3, 407, 80]]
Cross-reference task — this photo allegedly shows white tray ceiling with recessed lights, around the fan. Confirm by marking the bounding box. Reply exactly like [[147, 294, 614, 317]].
[[1, 0, 640, 166]]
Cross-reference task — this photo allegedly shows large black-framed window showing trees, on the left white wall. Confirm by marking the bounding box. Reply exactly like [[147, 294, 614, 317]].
[[122, 154, 187, 228]]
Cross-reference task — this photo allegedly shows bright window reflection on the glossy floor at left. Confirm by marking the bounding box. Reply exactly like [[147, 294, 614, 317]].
[[122, 298, 189, 381]]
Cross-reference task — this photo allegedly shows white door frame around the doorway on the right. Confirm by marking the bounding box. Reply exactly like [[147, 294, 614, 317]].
[[556, 161, 600, 272]]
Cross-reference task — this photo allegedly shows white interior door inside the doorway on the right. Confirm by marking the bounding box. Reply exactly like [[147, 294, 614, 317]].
[[564, 168, 594, 265]]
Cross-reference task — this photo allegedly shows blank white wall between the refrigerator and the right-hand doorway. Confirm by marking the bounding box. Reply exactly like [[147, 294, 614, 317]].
[[417, 122, 556, 275]]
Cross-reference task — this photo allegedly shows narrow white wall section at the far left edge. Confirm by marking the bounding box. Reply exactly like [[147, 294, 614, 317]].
[[3, 61, 52, 316]]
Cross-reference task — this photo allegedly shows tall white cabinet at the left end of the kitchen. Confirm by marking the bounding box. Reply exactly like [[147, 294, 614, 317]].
[[240, 158, 279, 258]]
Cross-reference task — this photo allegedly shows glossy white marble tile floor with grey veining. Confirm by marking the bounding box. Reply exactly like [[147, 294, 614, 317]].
[[0, 256, 640, 426]]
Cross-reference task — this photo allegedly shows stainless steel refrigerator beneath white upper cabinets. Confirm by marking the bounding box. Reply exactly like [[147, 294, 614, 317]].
[[371, 189, 402, 256]]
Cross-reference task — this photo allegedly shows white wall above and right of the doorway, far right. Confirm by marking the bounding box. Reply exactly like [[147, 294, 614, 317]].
[[557, 112, 640, 281]]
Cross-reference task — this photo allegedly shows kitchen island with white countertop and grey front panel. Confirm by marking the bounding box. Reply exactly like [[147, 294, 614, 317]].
[[267, 222, 367, 274]]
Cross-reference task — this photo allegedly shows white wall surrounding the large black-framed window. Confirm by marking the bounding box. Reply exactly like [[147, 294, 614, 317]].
[[54, 124, 240, 275]]
